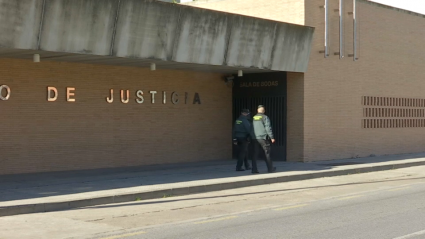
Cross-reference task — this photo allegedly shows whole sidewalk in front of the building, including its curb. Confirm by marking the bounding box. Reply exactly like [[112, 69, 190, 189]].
[[0, 153, 425, 216]]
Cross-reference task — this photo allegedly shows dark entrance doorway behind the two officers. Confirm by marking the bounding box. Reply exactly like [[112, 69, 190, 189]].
[[233, 72, 286, 161]]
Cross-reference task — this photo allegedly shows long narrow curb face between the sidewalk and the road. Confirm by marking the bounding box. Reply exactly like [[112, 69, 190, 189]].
[[0, 161, 425, 217]]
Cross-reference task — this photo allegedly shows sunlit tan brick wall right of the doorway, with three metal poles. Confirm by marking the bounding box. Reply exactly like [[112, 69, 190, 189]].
[[304, 0, 425, 161]]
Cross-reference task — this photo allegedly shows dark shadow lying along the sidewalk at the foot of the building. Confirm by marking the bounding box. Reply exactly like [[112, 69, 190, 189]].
[[0, 153, 425, 202]]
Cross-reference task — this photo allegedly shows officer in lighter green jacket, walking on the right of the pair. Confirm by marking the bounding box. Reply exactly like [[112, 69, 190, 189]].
[[251, 105, 276, 173]]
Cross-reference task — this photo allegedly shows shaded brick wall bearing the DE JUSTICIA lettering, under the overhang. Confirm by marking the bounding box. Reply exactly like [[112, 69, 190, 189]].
[[0, 59, 232, 174]]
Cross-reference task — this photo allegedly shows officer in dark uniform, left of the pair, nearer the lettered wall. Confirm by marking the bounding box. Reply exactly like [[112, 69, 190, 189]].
[[233, 109, 251, 171]]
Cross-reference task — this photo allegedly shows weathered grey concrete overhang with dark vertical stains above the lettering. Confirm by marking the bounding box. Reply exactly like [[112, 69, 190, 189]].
[[0, 0, 314, 73]]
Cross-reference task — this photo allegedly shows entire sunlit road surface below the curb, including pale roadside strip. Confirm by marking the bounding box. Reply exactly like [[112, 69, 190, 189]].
[[0, 166, 425, 239]]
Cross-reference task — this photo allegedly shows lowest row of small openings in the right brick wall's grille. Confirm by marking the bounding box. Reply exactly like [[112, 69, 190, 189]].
[[362, 119, 425, 129]]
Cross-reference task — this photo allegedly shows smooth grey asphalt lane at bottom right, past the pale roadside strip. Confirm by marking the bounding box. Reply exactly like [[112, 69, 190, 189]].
[[105, 182, 425, 239]]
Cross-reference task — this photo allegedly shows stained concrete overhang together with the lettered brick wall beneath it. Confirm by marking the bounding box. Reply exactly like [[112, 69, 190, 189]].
[[0, 0, 314, 174]]
